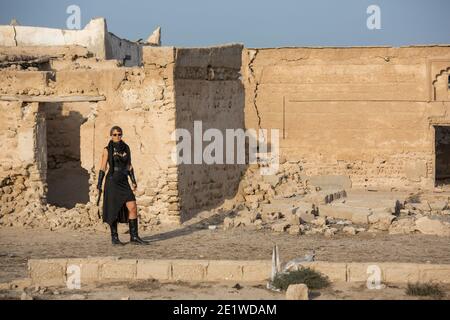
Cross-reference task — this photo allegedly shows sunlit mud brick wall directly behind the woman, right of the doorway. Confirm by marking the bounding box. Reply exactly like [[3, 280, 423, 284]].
[[91, 47, 180, 224]]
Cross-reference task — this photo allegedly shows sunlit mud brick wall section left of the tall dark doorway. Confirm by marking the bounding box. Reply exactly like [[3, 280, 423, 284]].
[[0, 101, 47, 224]]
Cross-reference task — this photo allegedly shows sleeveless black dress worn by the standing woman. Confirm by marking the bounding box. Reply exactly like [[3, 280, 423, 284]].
[[103, 142, 136, 224]]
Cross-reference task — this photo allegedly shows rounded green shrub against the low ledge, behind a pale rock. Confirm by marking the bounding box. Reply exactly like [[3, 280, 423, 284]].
[[272, 268, 330, 291]]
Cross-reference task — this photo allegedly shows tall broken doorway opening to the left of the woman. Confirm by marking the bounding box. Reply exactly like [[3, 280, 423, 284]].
[[39, 102, 89, 209]]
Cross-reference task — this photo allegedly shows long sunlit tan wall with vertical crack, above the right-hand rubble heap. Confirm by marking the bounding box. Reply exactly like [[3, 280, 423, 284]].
[[243, 46, 450, 188]]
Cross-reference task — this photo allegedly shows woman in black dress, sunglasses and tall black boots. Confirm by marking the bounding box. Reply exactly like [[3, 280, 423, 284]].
[[97, 126, 148, 245]]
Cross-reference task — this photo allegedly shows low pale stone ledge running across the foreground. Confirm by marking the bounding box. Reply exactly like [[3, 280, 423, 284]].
[[28, 257, 450, 286]]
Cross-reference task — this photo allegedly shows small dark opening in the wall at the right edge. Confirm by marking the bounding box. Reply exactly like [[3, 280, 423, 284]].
[[434, 126, 450, 185]]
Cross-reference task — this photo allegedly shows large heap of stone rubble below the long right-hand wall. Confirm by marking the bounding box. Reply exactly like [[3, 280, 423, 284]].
[[223, 169, 450, 237]]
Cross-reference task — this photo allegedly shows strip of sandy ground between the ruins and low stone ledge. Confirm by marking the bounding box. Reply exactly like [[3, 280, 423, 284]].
[[0, 226, 450, 282]]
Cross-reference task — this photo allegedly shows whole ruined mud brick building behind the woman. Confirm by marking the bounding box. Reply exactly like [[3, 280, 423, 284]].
[[0, 19, 450, 228]]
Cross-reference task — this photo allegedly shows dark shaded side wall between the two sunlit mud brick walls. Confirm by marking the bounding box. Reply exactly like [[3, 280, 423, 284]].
[[175, 45, 245, 219]]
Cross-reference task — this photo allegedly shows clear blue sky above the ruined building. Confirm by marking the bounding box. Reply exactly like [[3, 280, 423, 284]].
[[0, 0, 450, 48]]
